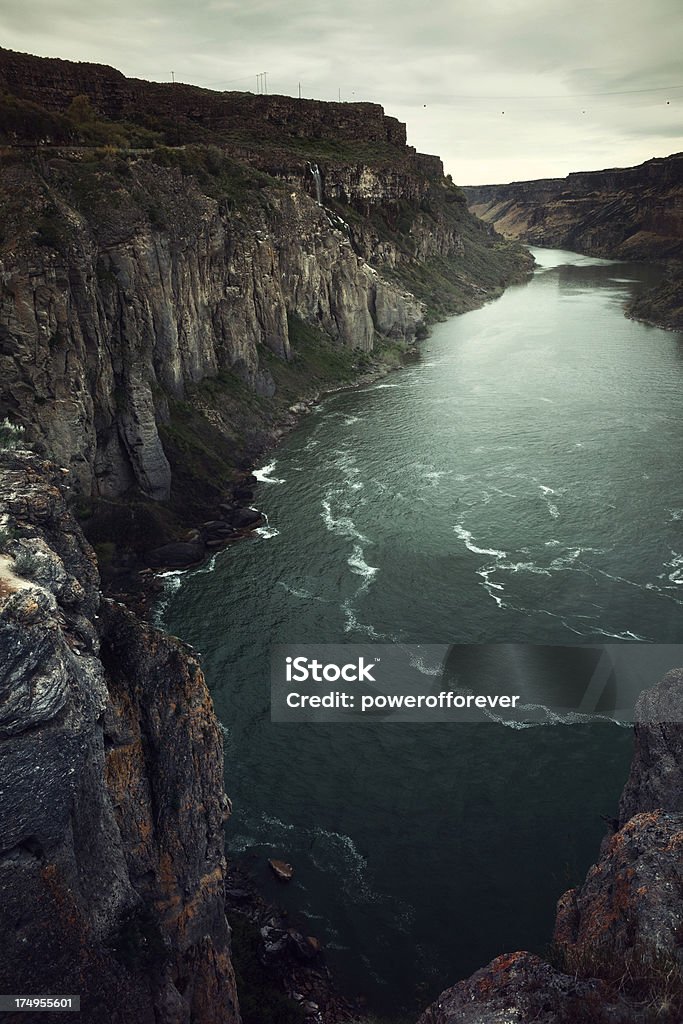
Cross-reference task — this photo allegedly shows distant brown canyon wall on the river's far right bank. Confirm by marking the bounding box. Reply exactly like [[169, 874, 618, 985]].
[[463, 153, 683, 331]]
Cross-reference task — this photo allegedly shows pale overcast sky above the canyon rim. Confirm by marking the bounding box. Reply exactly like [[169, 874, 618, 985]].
[[0, 0, 683, 184]]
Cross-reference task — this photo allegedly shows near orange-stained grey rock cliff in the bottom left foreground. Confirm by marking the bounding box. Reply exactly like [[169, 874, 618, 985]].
[[0, 452, 240, 1024]]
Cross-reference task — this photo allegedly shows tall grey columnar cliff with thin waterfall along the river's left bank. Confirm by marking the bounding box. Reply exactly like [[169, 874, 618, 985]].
[[0, 50, 529, 532]]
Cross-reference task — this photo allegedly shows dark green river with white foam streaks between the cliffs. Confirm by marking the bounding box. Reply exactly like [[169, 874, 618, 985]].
[[160, 249, 683, 1012]]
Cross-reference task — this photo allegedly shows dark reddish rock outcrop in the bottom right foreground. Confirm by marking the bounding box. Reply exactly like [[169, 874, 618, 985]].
[[420, 671, 683, 1024]]
